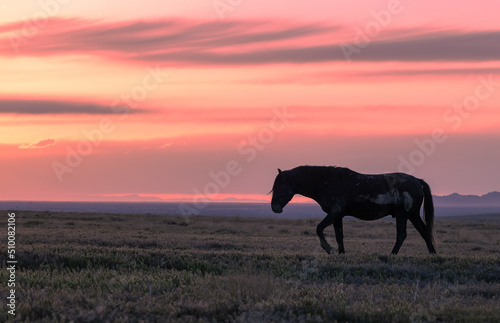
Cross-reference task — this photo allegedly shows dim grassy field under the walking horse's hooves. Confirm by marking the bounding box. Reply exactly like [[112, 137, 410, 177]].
[[0, 211, 500, 322]]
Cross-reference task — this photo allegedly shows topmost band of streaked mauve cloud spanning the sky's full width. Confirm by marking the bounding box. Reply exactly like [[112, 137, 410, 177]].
[[0, 18, 500, 65]]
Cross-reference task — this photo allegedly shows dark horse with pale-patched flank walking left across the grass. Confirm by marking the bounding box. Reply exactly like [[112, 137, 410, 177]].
[[271, 166, 436, 255]]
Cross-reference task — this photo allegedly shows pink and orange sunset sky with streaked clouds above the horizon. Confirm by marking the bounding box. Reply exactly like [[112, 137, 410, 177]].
[[0, 0, 500, 201]]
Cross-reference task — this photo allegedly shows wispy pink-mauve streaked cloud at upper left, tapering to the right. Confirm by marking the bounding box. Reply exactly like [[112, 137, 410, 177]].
[[0, 18, 335, 63]]
